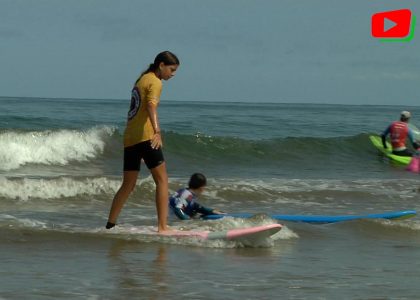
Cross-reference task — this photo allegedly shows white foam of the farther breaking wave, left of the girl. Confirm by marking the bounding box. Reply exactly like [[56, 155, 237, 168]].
[[0, 126, 116, 171]]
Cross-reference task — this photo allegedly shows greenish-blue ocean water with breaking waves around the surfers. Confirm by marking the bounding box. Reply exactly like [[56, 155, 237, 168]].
[[0, 97, 420, 299]]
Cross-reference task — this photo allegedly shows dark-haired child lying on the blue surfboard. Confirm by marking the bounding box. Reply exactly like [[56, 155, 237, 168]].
[[169, 173, 224, 220]]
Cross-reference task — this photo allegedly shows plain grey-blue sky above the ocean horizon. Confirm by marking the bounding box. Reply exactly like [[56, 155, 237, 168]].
[[0, 0, 420, 105]]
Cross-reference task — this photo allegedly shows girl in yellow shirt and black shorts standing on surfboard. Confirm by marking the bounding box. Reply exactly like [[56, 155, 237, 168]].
[[106, 51, 179, 232]]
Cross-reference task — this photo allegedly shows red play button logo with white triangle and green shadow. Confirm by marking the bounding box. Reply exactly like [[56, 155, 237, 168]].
[[372, 9, 415, 41]]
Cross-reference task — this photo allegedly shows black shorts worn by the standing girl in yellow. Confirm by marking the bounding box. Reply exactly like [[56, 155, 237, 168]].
[[124, 140, 165, 171]]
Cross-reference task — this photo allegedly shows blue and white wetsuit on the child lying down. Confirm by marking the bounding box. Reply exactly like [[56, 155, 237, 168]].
[[169, 188, 213, 220]]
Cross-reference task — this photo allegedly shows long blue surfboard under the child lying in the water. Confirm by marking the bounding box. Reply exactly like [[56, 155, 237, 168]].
[[203, 210, 416, 224]]
